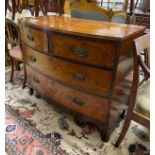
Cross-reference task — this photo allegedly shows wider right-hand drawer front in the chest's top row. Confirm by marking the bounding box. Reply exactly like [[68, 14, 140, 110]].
[[52, 34, 115, 68]]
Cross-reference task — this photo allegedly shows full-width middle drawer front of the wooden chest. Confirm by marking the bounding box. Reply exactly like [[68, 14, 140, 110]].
[[23, 46, 112, 96]]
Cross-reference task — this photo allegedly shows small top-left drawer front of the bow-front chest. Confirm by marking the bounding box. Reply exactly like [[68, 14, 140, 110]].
[[20, 26, 48, 52]]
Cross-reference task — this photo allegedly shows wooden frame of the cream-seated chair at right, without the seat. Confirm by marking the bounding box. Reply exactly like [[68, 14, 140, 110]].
[[115, 34, 150, 147]]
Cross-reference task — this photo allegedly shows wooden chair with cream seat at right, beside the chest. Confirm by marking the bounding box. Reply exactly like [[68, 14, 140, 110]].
[[115, 34, 150, 147]]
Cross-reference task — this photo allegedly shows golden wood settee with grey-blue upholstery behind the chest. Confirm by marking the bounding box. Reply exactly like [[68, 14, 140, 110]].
[[70, 0, 127, 23]]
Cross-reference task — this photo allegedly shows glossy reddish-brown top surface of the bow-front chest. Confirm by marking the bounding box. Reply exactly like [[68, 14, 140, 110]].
[[19, 16, 145, 41]]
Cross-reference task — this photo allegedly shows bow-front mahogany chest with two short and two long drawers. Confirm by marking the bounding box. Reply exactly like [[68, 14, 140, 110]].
[[19, 16, 145, 140]]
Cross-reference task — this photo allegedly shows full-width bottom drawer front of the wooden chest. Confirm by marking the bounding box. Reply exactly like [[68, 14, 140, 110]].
[[26, 66, 108, 122]]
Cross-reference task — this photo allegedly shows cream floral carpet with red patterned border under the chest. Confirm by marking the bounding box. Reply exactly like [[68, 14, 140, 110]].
[[5, 68, 149, 155]]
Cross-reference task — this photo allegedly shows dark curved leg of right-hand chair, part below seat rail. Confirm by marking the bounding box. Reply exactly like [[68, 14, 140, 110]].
[[114, 119, 131, 147]]
